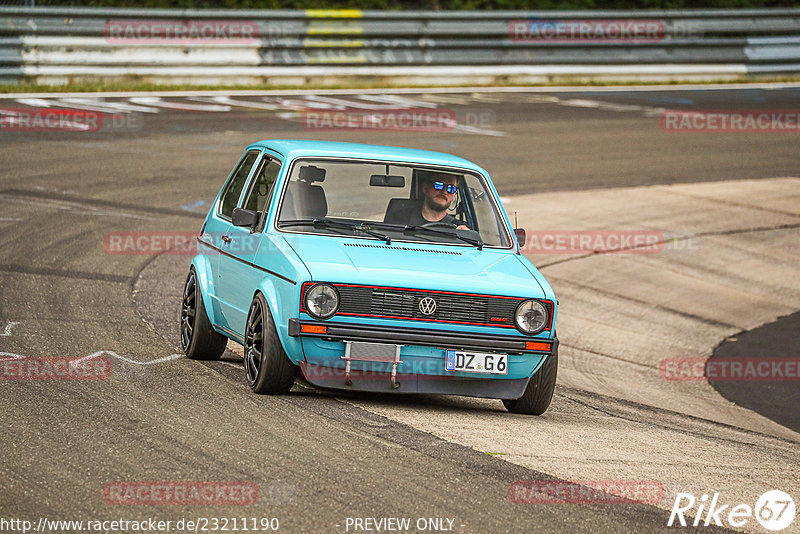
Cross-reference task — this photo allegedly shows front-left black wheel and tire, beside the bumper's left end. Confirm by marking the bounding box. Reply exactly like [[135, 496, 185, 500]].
[[244, 293, 298, 395]]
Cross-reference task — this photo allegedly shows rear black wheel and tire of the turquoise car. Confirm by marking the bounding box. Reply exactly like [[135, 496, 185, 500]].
[[180, 267, 228, 360]]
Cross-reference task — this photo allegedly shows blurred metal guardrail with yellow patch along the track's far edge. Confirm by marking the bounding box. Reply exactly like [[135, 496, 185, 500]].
[[0, 7, 800, 85]]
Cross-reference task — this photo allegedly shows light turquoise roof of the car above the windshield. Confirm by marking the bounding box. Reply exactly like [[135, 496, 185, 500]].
[[247, 139, 486, 174]]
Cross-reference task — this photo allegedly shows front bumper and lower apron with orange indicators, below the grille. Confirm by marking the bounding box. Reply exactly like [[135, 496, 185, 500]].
[[289, 319, 558, 399]]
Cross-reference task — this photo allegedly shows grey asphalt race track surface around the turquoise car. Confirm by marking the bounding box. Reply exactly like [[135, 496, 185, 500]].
[[0, 86, 800, 533]]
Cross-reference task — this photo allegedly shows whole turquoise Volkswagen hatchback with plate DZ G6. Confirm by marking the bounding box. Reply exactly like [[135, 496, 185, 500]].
[[180, 140, 558, 415]]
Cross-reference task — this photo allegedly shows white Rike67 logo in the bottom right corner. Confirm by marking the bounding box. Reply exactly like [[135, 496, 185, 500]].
[[667, 490, 796, 531]]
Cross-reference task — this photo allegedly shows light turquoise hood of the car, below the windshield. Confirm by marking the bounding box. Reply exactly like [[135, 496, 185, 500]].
[[284, 234, 545, 298]]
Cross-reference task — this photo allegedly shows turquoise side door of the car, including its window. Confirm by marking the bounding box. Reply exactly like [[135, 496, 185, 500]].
[[217, 153, 281, 337]]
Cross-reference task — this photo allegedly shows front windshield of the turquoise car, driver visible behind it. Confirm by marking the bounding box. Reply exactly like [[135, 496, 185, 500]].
[[277, 159, 511, 248]]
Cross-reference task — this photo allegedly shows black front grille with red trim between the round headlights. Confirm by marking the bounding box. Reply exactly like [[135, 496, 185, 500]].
[[336, 284, 523, 327]]
